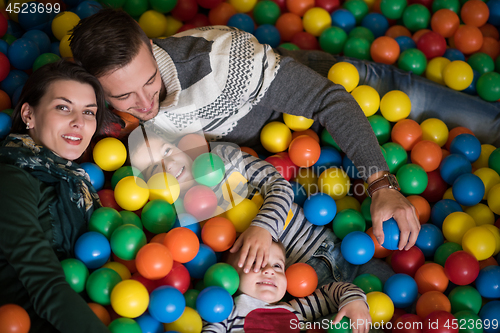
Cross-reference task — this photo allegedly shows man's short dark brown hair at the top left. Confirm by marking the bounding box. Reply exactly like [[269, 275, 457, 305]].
[[70, 8, 153, 78]]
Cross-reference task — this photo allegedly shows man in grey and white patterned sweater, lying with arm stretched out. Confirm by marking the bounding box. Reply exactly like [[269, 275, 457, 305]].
[[70, 10, 420, 249]]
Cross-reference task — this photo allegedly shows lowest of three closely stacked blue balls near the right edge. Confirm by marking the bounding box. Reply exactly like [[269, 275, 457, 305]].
[[452, 173, 485, 206]]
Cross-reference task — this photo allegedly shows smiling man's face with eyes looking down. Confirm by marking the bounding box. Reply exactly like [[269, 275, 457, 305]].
[[99, 44, 166, 120]]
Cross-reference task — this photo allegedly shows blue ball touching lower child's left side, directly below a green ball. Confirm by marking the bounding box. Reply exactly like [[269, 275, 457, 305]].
[[196, 286, 234, 323]]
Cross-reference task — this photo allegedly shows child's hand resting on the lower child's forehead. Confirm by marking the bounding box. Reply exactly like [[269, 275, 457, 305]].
[[229, 226, 273, 273]]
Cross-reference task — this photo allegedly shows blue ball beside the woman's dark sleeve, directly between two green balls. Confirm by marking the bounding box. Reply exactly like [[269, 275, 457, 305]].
[[75, 231, 111, 269]]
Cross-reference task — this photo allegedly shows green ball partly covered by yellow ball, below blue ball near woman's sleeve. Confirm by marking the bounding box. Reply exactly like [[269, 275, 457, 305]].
[[85, 268, 122, 305]]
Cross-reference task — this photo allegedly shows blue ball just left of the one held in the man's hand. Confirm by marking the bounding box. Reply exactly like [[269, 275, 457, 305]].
[[340, 231, 375, 265]]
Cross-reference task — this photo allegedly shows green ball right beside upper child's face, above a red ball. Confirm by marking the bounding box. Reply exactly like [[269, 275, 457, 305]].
[[192, 153, 226, 187]]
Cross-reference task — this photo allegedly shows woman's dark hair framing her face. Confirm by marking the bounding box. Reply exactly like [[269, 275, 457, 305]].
[[10, 60, 113, 134]]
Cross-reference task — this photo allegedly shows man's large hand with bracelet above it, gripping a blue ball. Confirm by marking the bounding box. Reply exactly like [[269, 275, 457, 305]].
[[370, 188, 420, 250]]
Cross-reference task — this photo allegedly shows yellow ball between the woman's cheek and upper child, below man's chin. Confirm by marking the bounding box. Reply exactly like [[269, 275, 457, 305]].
[[93, 137, 127, 171]]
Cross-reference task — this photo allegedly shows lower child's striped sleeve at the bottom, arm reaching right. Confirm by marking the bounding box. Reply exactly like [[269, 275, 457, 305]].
[[287, 282, 368, 321]]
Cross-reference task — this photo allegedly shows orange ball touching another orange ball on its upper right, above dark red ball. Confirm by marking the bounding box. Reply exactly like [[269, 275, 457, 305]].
[[135, 243, 174, 280]]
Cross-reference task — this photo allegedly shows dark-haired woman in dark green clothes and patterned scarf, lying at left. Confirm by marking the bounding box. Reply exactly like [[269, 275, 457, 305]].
[[0, 61, 109, 333]]
